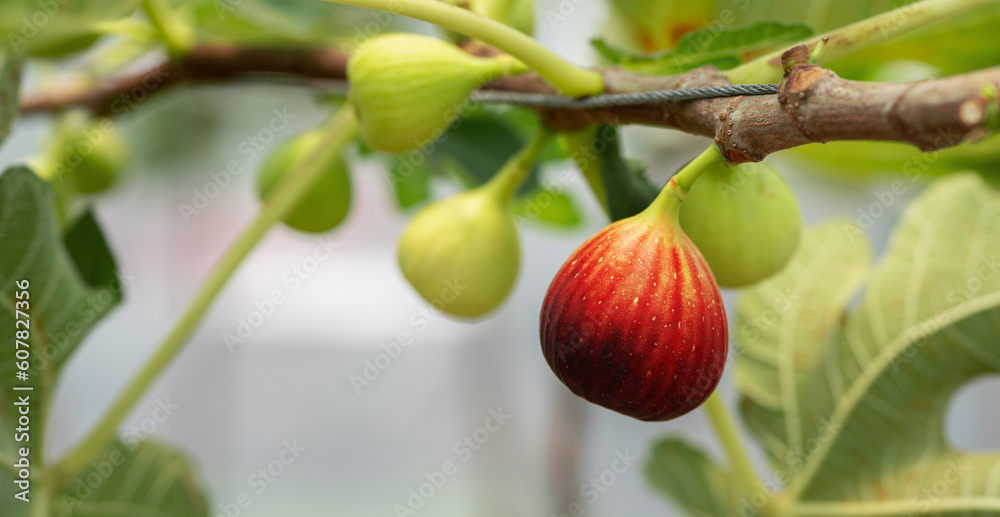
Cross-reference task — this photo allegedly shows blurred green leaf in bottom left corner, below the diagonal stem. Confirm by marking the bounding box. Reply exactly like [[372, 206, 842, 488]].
[[56, 440, 209, 517]]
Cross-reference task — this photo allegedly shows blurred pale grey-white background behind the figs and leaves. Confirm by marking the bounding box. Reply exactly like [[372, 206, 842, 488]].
[[0, 0, 1000, 517]]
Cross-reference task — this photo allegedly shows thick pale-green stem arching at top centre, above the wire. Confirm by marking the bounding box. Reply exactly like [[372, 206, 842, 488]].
[[324, 0, 604, 97]]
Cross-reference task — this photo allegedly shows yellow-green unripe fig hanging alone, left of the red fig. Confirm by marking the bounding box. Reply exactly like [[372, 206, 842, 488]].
[[399, 184, 521, 318]]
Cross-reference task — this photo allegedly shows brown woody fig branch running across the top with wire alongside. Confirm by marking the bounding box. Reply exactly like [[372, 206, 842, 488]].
[[22, 45, 1000, 163]]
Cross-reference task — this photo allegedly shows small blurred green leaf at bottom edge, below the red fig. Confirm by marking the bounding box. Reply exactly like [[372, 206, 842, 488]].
[[646, 437, 737, 517]]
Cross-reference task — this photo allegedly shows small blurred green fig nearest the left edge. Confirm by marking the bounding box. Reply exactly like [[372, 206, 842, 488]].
[[51, 113, 129, 194]]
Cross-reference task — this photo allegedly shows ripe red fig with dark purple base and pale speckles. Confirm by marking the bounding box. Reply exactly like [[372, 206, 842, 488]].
[[540, 159, 728, 421]]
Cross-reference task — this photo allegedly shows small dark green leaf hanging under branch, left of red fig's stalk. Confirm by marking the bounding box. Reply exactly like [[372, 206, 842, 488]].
[[592, 127, 660, 221]]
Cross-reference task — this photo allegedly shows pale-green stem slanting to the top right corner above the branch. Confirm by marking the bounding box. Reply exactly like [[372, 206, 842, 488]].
[[723, 0, 995, 84]]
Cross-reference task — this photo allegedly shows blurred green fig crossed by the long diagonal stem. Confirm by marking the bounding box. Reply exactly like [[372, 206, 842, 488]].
[[257, 130, 351, 233]]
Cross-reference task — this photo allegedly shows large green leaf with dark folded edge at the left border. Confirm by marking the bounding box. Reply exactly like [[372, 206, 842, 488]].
[[0, 167, 121, 516]]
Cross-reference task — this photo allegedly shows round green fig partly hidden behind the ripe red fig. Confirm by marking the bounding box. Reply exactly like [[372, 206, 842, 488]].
[[680, 162, 802, 287]]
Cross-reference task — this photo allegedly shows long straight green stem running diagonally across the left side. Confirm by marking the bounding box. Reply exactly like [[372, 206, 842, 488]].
[[53, 108, 357, 484]]
